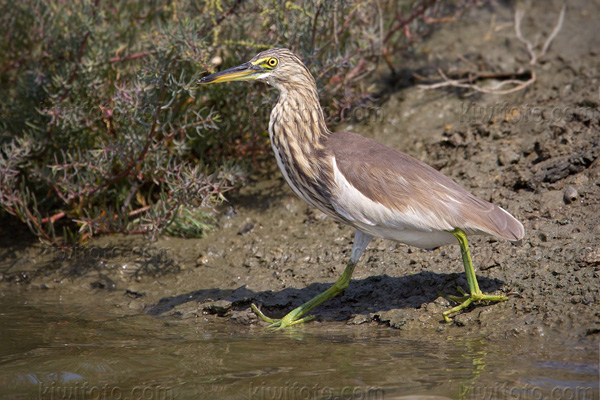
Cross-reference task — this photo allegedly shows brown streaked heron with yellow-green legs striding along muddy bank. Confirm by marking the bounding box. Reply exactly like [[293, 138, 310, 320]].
[[199, 48, 525, 329]]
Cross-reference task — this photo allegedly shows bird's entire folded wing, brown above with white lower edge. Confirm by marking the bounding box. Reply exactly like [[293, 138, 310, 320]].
[[325, 132, 524, 241]]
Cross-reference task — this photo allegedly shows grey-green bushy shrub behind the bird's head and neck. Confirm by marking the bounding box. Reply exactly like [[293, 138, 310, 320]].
[[0, 0, 454, 245]]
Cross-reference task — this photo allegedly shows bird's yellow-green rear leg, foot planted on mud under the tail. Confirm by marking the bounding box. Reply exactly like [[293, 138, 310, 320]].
[[443, 228, 508, 322]]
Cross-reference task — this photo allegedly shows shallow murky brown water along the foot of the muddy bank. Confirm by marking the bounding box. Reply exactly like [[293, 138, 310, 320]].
[[0, 292, 599, 400]]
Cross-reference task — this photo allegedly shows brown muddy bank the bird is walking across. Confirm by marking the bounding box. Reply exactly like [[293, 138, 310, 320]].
[[0, 0, 600, 340]]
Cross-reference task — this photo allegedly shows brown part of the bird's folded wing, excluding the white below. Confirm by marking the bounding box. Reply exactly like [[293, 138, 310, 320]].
[[325, 132, 524, 241]]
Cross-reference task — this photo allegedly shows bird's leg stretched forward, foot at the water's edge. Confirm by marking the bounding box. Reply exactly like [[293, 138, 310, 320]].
[[251, 229, 372, 329]]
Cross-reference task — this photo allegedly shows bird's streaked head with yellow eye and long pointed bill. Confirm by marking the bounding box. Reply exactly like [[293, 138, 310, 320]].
[[199, 48, 314, 89]]
